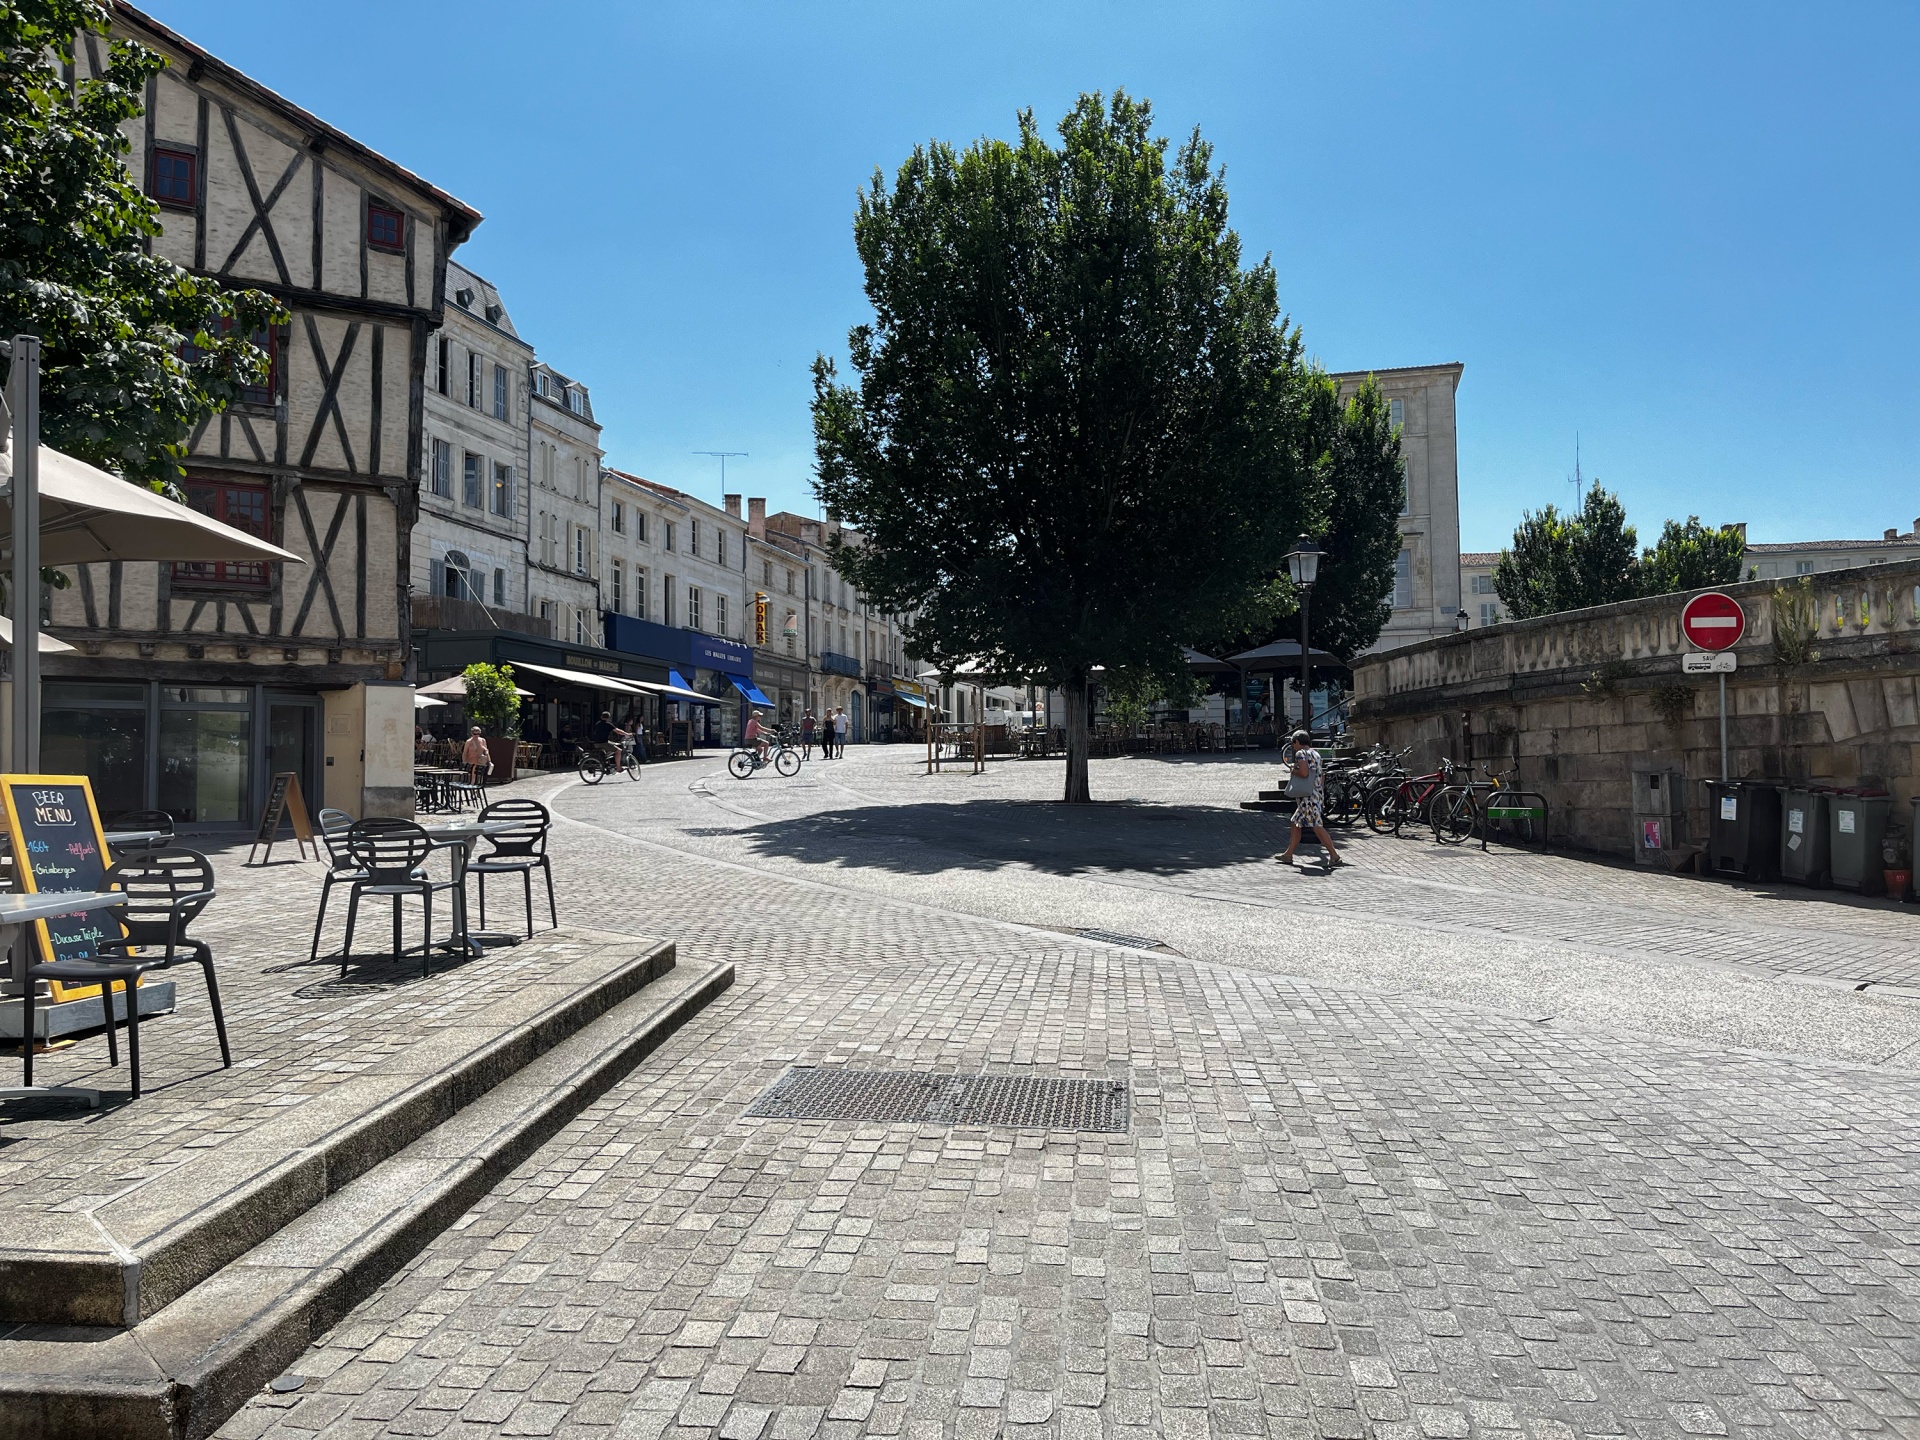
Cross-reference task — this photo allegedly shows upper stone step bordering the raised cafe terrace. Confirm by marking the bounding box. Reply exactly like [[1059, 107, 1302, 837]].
[[0, 931, 674, 1325]]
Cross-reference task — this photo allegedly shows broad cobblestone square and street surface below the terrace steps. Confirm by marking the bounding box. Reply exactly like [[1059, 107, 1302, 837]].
[[210, 751, 1920, 1440]]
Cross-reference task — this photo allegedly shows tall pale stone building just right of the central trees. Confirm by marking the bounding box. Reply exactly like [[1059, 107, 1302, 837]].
[[1334, 365, 1465, 651]]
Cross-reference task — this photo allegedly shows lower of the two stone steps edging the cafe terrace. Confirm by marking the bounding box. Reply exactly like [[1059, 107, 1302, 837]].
[[0, 962, 733, 1440]]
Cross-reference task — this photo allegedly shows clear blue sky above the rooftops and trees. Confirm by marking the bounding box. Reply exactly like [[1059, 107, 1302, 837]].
[[150, 0, 1920, 549]]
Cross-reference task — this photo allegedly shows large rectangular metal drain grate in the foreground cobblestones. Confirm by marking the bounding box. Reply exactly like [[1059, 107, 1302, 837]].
[[747, 1066, 1127, 1135]]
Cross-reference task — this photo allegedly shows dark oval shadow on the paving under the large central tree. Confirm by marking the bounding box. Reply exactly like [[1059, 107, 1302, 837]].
[[737, 801, 1286, 876]]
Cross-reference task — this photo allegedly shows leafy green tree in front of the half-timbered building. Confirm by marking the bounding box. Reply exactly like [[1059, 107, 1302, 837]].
[[0, 0, 284, 488]]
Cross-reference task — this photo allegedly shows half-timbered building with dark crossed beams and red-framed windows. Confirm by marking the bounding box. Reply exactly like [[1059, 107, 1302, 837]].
[[42, 4, 480, 826]]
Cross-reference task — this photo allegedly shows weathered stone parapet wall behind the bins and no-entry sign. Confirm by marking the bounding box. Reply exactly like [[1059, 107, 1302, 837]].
[[1354, 563, 1920, 854]]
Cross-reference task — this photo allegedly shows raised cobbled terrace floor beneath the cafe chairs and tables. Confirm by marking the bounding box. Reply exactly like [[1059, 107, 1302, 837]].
[[0, 839, 656, 1221]]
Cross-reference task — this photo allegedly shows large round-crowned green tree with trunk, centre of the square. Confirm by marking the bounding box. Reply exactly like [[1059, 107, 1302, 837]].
[[814, 92, 1325, 801]]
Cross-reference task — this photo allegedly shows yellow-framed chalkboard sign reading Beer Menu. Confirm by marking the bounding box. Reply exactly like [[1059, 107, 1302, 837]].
[[0, 776, 121, 1000]]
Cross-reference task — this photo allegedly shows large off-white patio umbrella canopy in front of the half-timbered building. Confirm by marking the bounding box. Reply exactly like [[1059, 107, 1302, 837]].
[[0, 445, 305, 566]]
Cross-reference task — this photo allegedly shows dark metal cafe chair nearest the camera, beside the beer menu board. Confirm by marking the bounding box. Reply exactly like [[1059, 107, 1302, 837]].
[[27, 847, 234, 1100]]
